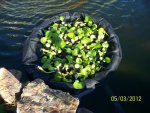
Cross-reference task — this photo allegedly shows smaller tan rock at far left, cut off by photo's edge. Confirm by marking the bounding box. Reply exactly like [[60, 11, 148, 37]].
[[0, 68, 22, 109]]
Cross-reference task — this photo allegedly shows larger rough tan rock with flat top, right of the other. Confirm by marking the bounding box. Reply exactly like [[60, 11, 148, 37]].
[[17, 79, 79, 113]]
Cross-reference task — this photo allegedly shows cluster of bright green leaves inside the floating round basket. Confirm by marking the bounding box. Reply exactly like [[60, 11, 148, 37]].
[[40, 16, 111, 89]]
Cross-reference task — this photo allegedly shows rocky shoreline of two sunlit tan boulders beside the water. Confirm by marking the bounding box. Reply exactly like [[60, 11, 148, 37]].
[[0, 68, 79, 113]]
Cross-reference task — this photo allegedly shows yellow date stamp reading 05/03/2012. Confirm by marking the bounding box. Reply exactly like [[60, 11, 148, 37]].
[[110, 96, 142, 102]]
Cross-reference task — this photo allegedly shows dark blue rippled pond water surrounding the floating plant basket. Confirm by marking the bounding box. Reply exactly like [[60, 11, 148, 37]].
[[0, 0, 150, 113]]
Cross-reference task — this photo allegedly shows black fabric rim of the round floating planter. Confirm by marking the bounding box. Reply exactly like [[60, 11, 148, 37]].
[[22, 12, 122, 95]]
